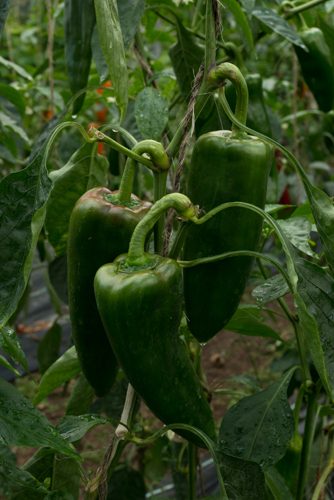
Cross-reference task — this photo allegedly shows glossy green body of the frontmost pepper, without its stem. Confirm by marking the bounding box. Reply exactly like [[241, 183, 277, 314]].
[[95, 254, 215, 446]]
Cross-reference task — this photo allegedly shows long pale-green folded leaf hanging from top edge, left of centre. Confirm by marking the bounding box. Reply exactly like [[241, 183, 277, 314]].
[[94, 0, 128, 121]]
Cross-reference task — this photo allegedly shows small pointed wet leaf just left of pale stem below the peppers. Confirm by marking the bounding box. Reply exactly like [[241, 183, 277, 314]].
[[58, 415, 110, 443]]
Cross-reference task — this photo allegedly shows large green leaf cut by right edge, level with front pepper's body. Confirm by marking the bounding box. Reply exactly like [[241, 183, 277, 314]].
[[295, 259, 334, 401]]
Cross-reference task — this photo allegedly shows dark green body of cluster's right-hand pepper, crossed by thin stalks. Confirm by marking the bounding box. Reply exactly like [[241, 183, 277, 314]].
[[183, 131, 272, 342]]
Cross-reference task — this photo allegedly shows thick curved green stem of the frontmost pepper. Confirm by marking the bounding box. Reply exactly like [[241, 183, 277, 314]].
[[126, 193, 197, 267]]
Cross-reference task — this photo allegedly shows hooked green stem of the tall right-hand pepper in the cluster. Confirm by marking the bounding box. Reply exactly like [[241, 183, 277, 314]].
[[208, 62, 248, 134]]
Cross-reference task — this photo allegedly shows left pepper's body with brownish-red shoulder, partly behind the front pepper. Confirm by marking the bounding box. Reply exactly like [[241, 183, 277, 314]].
[[67, 187, 150, 396]]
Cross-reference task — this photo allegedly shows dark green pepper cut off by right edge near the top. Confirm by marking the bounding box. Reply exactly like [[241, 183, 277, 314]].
[[295, 28, 334, 112]]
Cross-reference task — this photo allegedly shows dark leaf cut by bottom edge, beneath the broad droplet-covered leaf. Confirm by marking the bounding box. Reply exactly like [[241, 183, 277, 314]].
[[218, 453, 267, 500]]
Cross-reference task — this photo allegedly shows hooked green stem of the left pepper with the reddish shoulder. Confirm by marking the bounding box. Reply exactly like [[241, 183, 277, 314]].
[[118, 139, 170, 203]]
